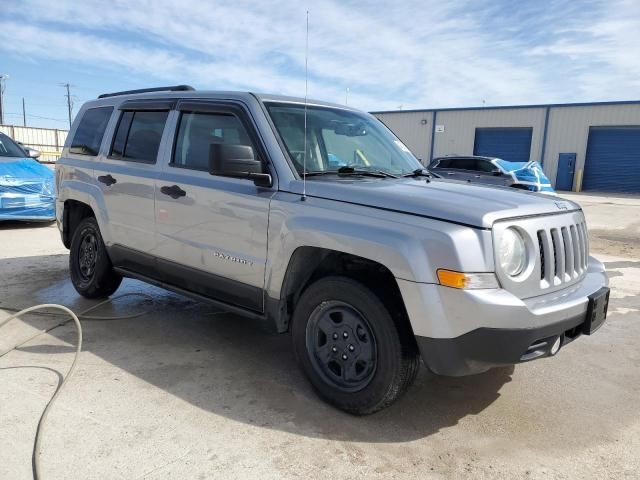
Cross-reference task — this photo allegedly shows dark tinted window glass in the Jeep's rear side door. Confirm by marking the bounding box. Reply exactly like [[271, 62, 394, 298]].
[[110, 111, 169, 163]]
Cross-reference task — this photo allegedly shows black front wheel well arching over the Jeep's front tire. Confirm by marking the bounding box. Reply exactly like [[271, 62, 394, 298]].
[[276, 247, 413, 338]]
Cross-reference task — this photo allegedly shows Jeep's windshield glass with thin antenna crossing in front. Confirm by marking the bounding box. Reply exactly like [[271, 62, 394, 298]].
[[267, 103, 422, 175]]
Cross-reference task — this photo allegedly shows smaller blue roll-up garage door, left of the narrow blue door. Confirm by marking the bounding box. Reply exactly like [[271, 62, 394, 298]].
[[473, 128, 533, 162]]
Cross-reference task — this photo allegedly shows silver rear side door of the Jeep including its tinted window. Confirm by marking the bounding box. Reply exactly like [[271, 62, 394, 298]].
[[94, 100, 175, 274]]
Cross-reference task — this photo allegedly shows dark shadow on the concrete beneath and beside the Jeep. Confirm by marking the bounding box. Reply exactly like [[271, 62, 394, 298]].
[[0, 255, 513, 442]]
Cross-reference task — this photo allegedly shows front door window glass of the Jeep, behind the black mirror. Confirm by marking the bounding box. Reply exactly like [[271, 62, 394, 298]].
[[171, 112, 255, 172]]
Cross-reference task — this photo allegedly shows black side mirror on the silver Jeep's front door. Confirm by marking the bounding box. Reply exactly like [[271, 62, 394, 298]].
[[209, 143, 273, 187]]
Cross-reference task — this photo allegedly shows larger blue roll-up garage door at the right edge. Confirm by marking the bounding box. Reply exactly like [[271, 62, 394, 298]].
[[582, 126, 640, 193]]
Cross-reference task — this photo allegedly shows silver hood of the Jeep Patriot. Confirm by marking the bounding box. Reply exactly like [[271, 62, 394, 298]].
[[284, 177, 580, 228]]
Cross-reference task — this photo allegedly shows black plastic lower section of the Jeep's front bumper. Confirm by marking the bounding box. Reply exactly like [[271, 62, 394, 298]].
[[416, 314, 586, 376]]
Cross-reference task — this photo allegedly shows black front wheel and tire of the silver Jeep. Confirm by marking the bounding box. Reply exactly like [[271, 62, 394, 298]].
[[291, 277, 420, 415]]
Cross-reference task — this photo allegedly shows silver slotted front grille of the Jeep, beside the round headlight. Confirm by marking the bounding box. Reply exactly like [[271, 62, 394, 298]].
[[537, 221, 589, 289]]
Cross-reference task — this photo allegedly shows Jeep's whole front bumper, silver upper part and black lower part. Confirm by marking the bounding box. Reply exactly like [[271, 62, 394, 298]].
[[398, 257, 608, 376]]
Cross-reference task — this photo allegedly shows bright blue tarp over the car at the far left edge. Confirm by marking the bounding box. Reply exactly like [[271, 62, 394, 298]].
[[0, 158, 56, 220]]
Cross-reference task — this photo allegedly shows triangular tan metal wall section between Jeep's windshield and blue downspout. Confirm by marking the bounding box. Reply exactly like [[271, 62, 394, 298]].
[[375, 112, 433, 164]]
